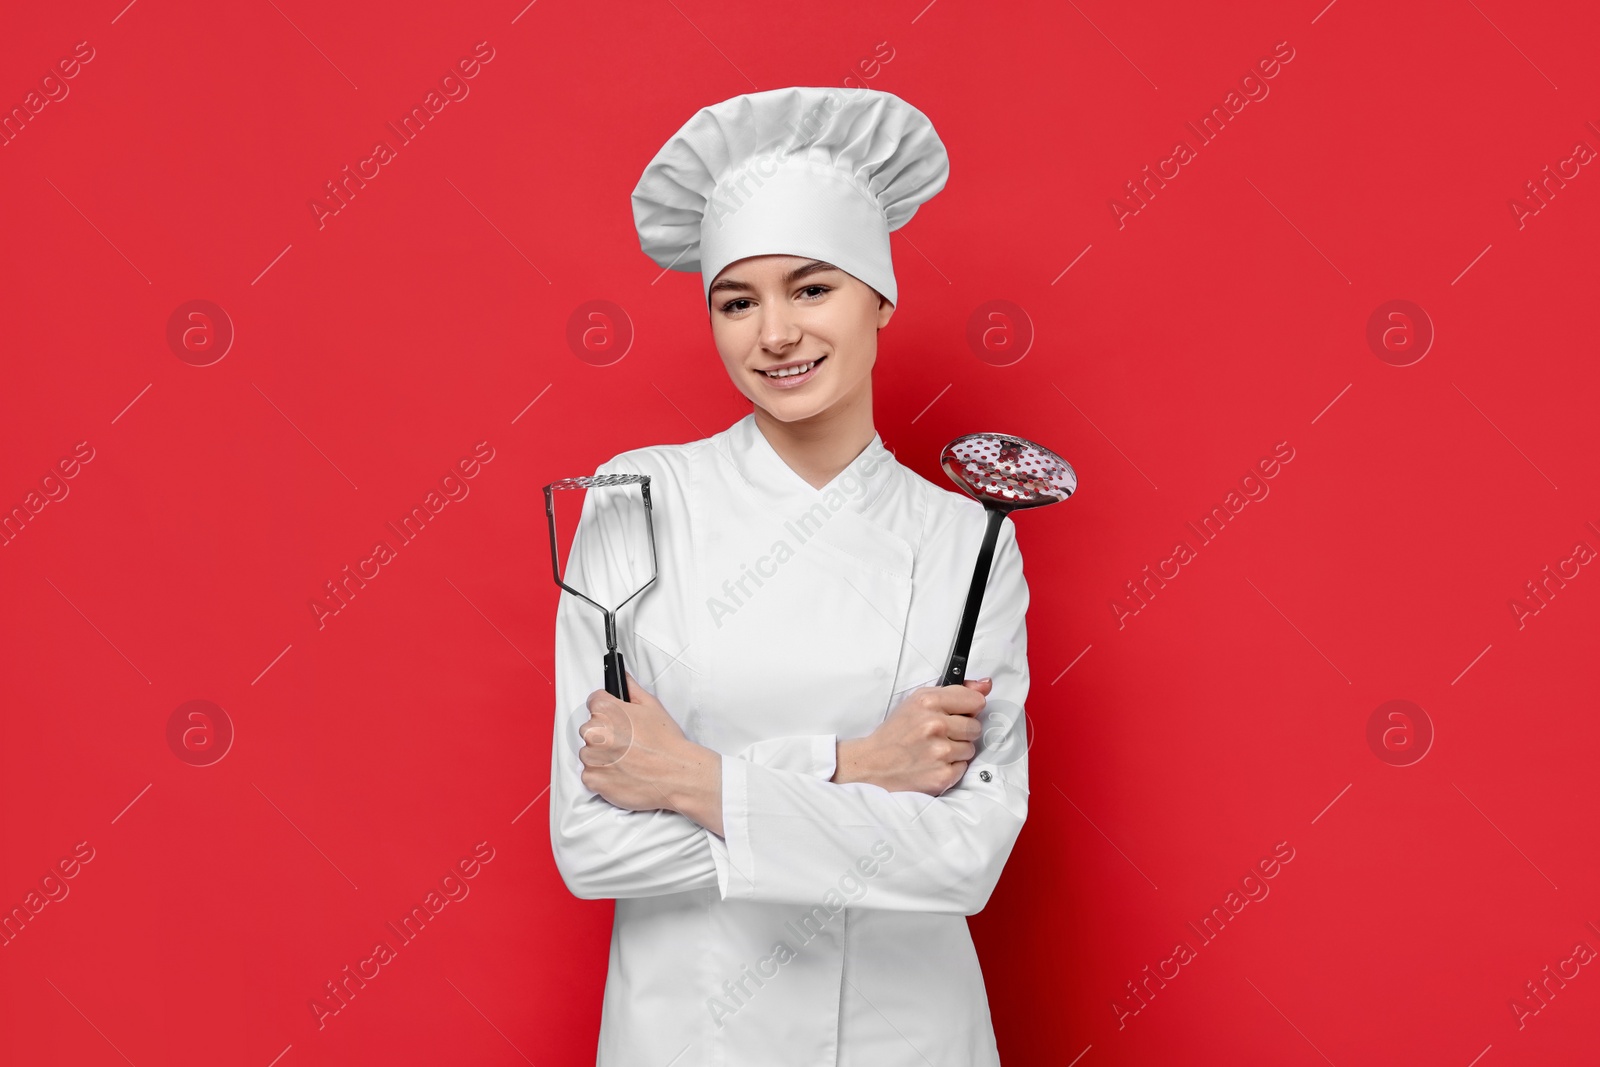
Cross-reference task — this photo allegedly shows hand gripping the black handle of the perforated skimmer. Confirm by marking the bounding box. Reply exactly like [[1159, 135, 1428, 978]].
[[830, 678, 994, 797]]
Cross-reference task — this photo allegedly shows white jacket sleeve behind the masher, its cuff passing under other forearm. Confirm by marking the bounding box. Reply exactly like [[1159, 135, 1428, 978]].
[[550, 456, 835, 901]]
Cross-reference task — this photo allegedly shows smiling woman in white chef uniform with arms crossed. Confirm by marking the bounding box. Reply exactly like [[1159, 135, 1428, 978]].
[[550, 86, 1029, 1067]]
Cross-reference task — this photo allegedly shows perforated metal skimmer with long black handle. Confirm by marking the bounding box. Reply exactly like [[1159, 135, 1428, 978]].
[[939, 434, 1078, 685]]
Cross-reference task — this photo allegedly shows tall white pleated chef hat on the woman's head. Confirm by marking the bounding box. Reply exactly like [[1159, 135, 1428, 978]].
[[634, 85, 950, 304]]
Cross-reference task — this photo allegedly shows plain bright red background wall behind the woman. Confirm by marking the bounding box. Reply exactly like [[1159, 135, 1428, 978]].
[[0, 0, 1600, 1067]]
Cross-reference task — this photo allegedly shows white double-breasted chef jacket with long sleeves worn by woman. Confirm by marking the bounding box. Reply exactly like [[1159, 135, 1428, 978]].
[[550, 414, 1029, 1067]]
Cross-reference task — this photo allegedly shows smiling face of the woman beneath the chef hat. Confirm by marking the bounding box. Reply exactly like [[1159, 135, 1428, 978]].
[[710, 256, 894, 422]]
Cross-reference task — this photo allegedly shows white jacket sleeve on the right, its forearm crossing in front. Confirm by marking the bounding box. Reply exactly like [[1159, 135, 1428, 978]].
[[706, 520, 1029, 915]]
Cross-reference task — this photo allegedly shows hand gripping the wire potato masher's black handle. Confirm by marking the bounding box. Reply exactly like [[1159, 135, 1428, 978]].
[[578, 675, 722, 832]]
